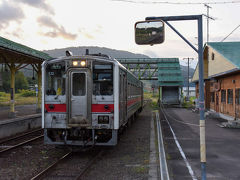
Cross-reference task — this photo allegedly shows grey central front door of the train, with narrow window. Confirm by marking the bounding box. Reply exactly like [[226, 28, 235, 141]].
[[69, 70, 92, 126]]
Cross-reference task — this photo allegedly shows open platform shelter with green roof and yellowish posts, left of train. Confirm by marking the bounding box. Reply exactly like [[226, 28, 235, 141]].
[[0, 37, 51, 117]]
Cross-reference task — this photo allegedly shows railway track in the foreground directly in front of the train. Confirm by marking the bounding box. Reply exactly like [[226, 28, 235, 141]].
[[31, 150, 104, 180]]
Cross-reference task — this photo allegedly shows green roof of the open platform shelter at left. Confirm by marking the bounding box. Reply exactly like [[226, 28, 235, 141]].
[[0, 37, 52, 63]]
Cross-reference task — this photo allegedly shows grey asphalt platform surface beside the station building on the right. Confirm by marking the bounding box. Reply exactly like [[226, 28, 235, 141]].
[[161, 108, 240, 180]]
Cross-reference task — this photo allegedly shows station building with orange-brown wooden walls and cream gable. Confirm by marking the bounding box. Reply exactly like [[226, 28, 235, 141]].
[[192, 42, 240, 120]]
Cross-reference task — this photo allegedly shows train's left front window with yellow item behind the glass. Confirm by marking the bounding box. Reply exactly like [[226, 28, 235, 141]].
[[46, 64, 66, 96]]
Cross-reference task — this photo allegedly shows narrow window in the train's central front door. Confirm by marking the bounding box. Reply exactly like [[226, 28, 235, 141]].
[[72, 73, 86, 96]]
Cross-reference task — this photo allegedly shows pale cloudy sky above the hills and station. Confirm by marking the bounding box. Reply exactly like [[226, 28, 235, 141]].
[[0, 0, 240, 67]]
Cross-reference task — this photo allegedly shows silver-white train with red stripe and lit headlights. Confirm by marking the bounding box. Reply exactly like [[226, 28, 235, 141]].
[[42, 52, 143, 146]]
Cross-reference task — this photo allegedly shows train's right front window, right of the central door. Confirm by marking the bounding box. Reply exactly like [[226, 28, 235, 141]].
[[93, 64, 113, 95]]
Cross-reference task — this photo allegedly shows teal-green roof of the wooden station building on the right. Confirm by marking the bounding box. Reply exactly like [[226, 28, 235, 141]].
[[207, 42, 240, 68]]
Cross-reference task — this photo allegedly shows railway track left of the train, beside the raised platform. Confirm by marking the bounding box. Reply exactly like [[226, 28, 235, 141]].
[[0, 129, 43, 154]]
